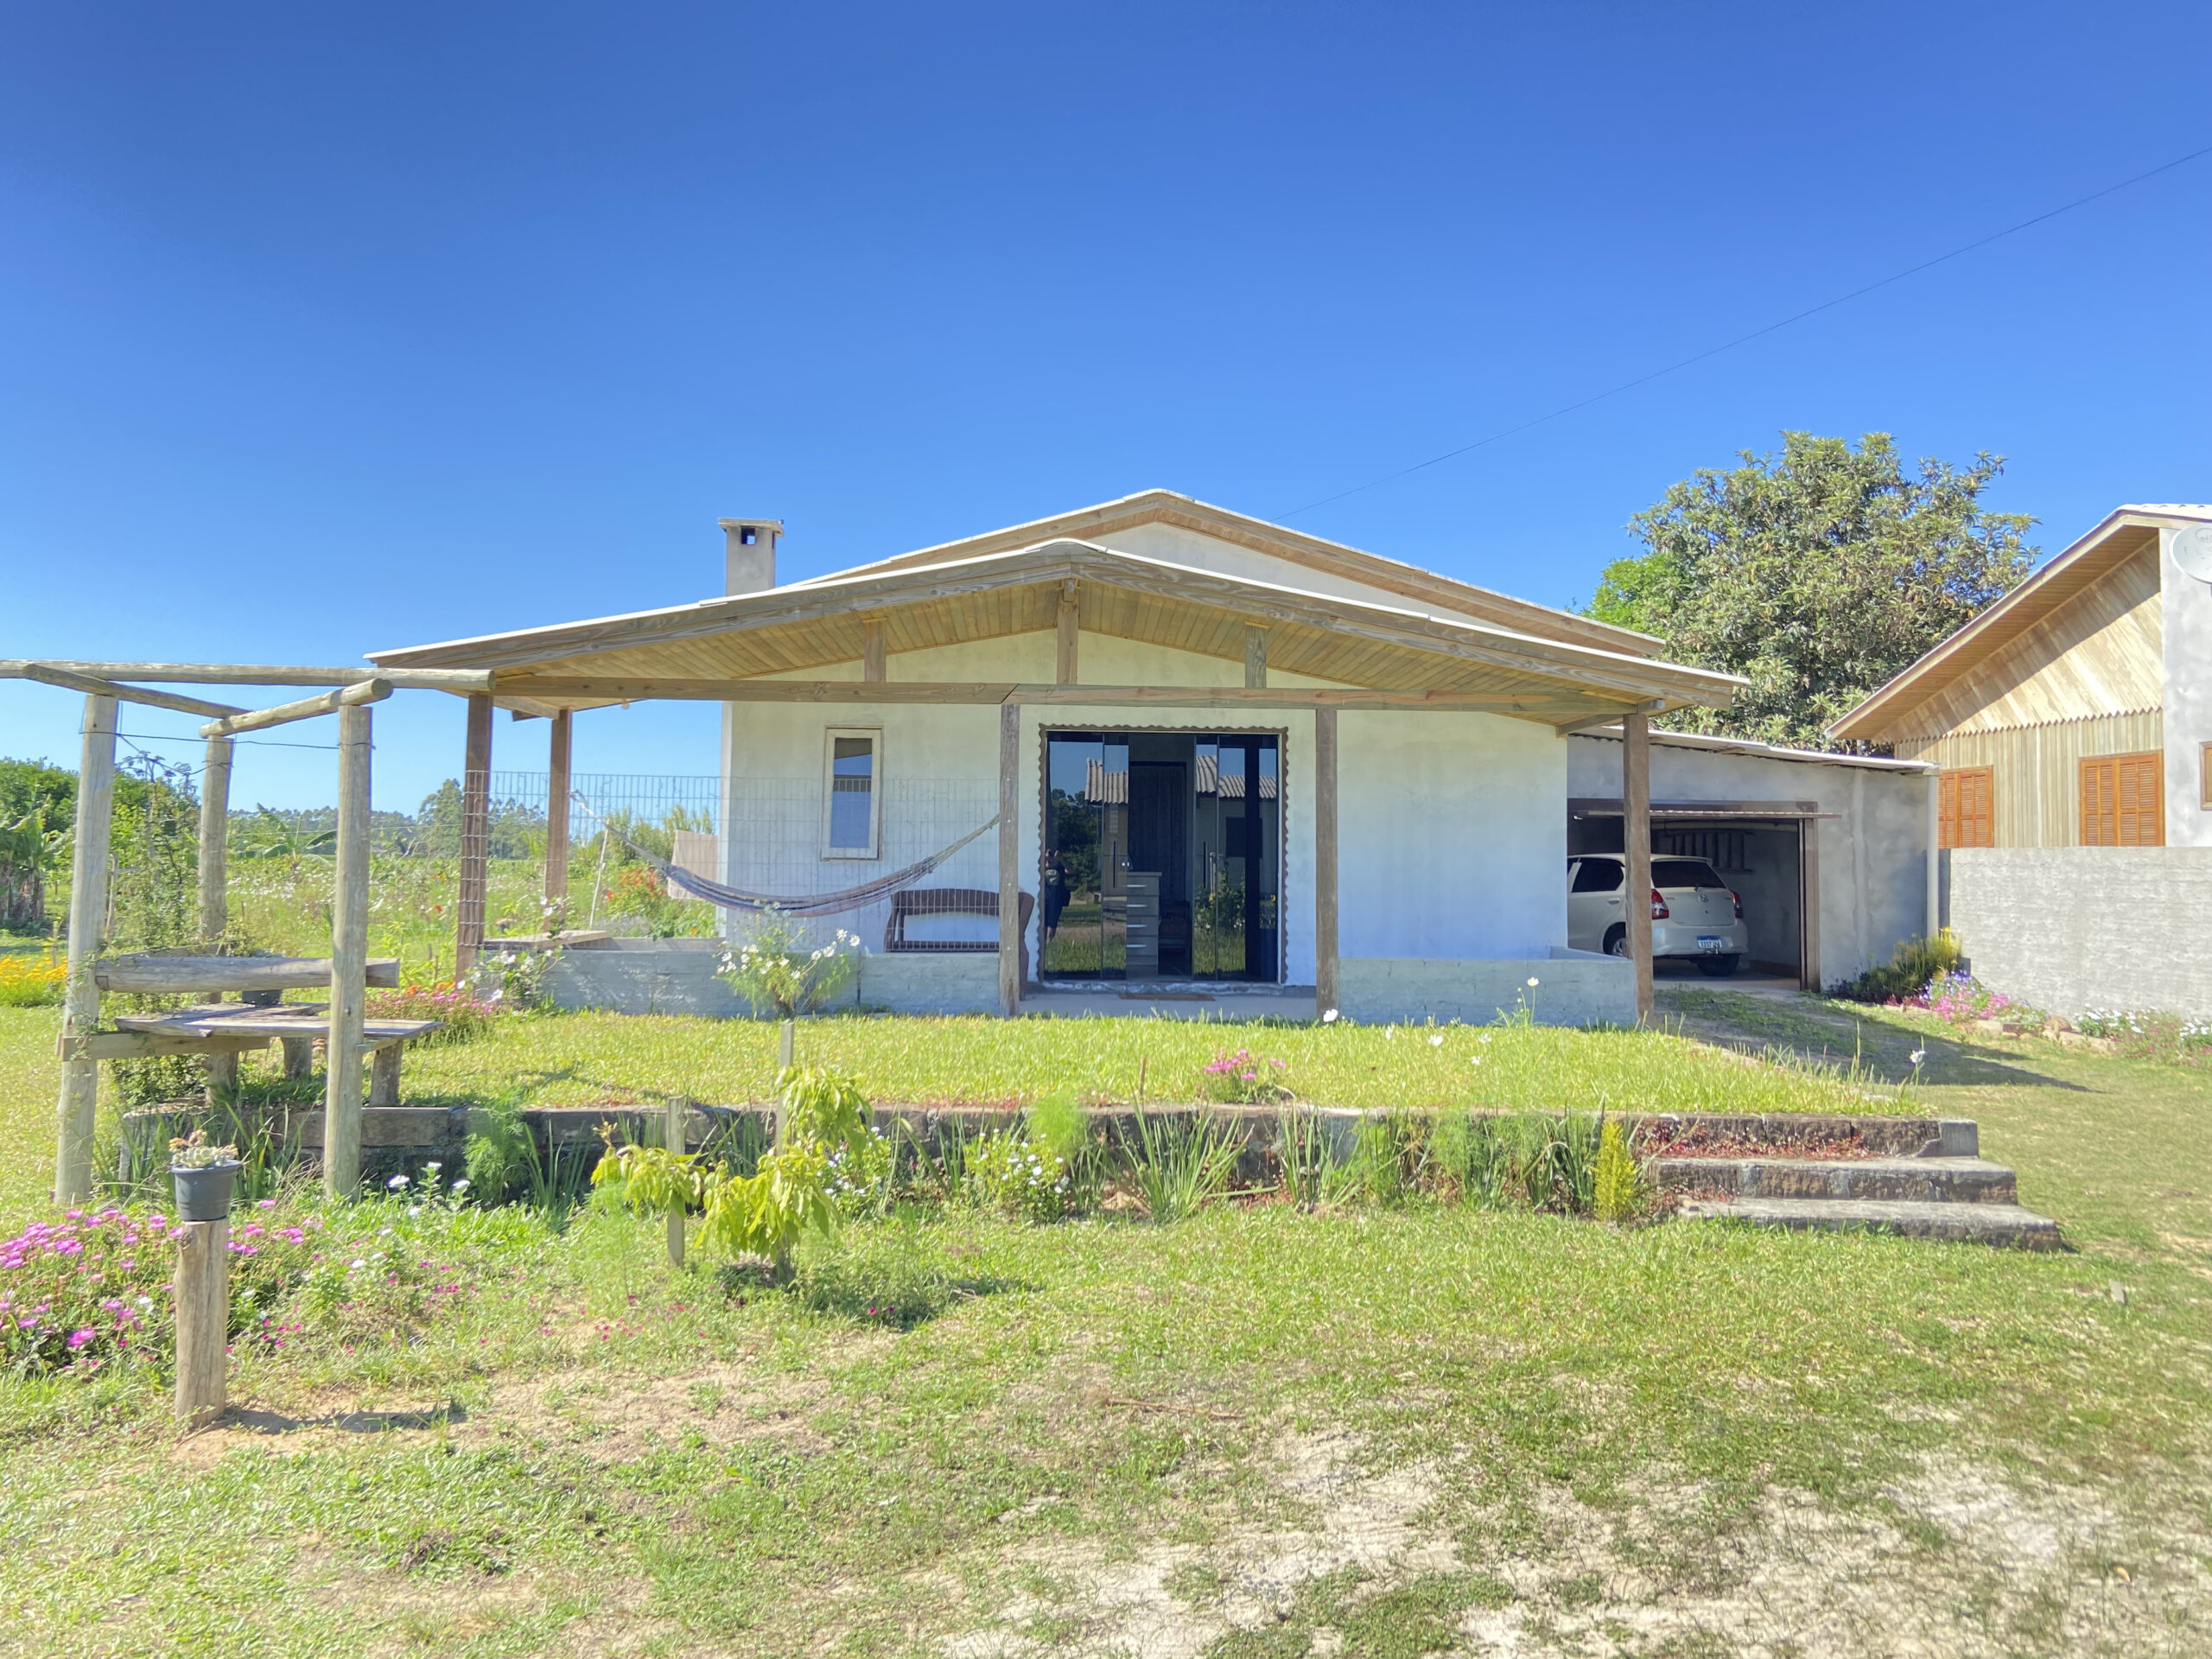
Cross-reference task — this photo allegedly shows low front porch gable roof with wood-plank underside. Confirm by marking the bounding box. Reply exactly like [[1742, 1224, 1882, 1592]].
[[372, 537, 1743, 721]]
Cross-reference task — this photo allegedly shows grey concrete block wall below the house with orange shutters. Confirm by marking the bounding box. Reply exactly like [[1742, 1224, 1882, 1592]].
[[1942, 847, 2212, 1018]]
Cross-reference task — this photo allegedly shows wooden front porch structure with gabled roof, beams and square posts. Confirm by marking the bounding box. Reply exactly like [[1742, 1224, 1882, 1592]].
[[372, 532, 1743, 1015]]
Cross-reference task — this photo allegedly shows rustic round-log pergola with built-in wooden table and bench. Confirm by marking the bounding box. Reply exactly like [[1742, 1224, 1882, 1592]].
[[0, 659, 491, 1204]]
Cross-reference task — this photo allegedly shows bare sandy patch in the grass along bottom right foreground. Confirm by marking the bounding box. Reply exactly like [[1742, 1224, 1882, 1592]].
[[943, 1435, 2212, 1659]]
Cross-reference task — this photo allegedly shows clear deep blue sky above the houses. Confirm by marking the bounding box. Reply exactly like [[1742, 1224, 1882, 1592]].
[[0, 3, 2212, 807]]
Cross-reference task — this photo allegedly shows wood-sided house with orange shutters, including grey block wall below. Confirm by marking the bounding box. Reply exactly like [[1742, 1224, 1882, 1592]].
[[1832, 505, 2212, 1015]]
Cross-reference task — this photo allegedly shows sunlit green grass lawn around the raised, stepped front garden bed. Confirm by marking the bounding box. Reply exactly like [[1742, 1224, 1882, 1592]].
[[0, 988, 2212, 1659]]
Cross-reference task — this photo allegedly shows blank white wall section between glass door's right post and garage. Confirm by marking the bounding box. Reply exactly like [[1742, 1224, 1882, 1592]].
[[1336, 710, 1566, 960]]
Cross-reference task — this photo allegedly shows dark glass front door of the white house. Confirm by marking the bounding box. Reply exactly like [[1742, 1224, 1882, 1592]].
[[1039, 732, 1283, 982]]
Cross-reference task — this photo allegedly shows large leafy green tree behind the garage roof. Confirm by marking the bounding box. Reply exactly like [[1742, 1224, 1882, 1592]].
[[1588, 431, 2035, 747]]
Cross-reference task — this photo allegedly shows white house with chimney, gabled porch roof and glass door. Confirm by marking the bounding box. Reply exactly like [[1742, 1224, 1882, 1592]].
[[374, 491, 1741, 1022]]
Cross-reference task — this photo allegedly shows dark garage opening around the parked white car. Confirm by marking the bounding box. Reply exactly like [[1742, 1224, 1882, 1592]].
[[1566, 798, 1834, 991]]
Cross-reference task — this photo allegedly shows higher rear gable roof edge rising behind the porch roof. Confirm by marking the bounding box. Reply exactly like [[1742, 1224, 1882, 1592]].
[[791, 489, 1666, 657]]
